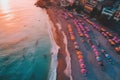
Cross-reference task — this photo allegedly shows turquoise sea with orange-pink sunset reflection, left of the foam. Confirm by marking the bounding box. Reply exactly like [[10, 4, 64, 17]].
[[0, 0, 52, 80]]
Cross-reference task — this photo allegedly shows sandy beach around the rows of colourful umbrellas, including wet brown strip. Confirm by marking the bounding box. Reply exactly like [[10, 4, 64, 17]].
[[35, 0, 120, 80]]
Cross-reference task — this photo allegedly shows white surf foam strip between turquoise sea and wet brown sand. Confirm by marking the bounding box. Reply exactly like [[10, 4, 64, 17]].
[[48, 12, 59, 80]]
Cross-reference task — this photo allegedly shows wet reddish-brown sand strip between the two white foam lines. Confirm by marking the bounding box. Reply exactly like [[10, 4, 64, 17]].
[[47, 8, 70, 80]]
